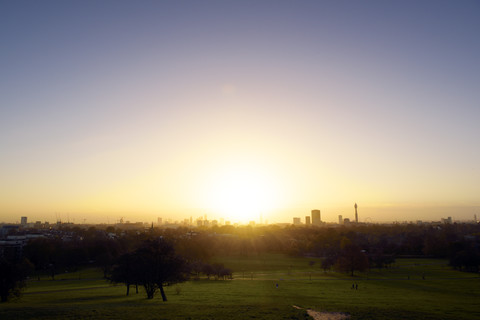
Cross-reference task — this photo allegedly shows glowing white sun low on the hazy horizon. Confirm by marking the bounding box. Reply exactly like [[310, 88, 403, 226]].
[[199, 163, 281, 223]]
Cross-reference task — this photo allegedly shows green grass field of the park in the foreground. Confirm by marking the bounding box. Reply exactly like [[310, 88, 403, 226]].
[[0, 255, 480, 320]]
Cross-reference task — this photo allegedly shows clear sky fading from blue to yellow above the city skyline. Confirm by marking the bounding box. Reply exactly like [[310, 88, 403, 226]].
[[0, 0, 480, 223]]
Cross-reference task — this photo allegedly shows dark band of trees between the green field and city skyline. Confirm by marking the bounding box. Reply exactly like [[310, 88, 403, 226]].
[[0, 224, 480, 301]]
